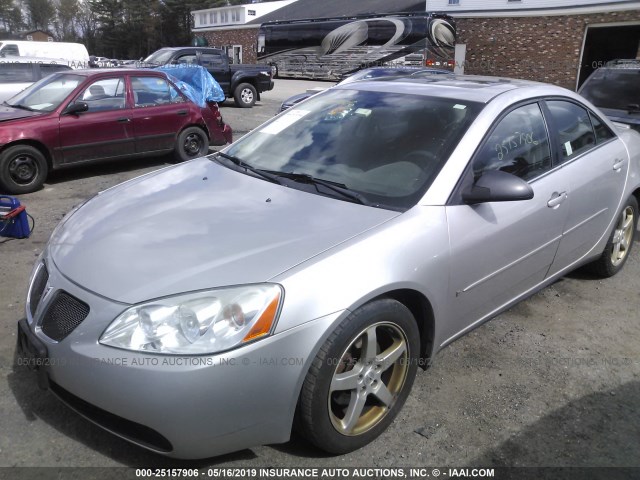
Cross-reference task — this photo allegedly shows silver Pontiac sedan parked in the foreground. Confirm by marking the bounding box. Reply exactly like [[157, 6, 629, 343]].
[[18, 75, 640, 458]]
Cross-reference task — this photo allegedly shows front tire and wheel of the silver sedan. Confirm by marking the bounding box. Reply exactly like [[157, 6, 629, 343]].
[[296, 299, 419, 454]]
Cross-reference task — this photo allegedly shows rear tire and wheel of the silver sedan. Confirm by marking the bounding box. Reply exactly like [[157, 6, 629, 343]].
[[591, 195, 638, 278]]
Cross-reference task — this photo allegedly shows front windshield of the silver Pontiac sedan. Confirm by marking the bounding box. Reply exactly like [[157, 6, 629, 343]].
[[225, 89, 482, 211]]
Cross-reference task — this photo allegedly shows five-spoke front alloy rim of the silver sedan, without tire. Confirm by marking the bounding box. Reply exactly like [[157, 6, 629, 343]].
[[328, 322, 409, 436]]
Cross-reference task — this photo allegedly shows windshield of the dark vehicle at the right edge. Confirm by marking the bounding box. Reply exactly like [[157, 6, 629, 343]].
[[580, 68, 640, 110]]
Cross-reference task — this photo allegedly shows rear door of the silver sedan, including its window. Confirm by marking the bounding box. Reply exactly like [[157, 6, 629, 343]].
[[546, 99, 629, 275]]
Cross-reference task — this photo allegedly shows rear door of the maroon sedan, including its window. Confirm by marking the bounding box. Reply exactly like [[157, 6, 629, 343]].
[[130, 75, 192, 153]]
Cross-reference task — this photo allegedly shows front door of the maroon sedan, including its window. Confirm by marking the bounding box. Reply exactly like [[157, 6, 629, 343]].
[[60, 75, 135, 164]]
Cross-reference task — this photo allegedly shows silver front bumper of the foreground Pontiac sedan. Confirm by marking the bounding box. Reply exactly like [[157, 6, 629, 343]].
[[21, 256, 340, 458]]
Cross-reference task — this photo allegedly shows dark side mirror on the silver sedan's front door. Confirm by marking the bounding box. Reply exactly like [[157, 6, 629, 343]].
[[462, 170, 533, 205]]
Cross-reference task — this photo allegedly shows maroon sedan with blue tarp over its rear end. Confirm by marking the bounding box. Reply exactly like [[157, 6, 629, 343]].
[[0, 69, 232, 194]]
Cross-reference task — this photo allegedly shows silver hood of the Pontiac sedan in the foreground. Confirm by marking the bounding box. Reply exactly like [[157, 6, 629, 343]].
[[49, 158, 399, 303]]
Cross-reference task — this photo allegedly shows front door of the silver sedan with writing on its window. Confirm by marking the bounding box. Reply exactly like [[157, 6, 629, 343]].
[[439, 103, 569, 343]]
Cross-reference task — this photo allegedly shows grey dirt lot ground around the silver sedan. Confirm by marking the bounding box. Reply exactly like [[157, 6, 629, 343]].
[[0, 81, 640, 470]]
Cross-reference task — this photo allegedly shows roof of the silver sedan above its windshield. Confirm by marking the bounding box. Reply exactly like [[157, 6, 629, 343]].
[[334, 72, 568, 103]]
